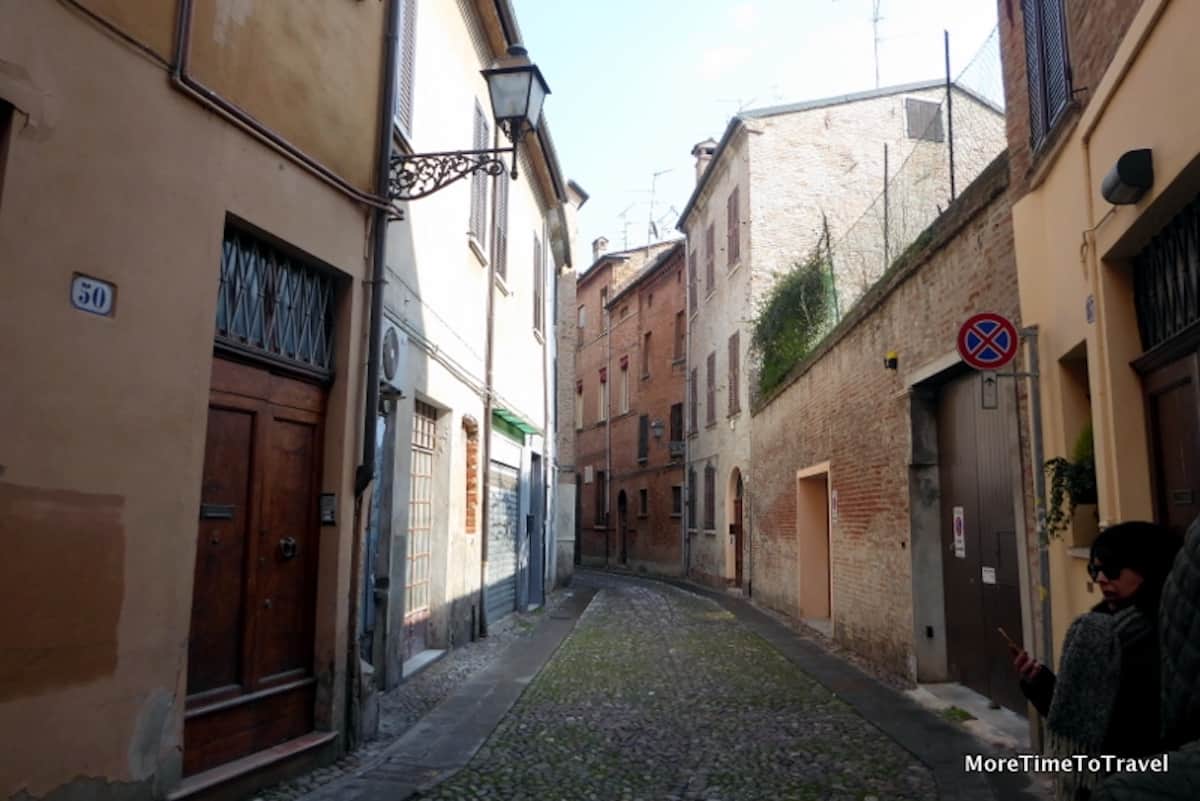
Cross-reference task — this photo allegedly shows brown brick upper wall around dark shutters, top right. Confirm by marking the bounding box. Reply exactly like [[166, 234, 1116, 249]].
[[998, 0, 1142, 200]]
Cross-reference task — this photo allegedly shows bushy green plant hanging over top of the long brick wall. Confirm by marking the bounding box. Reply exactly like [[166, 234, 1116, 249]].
[[751, 234, 836, 395]]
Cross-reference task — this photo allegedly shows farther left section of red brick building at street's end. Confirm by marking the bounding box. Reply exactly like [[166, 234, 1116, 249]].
[[574, 237, 672, 565]]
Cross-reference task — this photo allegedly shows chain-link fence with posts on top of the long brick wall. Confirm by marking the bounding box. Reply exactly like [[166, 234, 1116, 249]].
[[829, 22, 1006, 316]]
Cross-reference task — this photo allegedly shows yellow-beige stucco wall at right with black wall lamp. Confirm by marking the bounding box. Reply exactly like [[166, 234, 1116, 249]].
[[1013, 0, 1200, 644]]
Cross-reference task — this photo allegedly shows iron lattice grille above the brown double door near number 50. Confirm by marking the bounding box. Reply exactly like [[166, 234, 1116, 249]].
[[216, 228, 337, 378]]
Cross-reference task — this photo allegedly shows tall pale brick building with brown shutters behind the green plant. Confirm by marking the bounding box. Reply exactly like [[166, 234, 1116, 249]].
[[679, 82, 1003, 592]]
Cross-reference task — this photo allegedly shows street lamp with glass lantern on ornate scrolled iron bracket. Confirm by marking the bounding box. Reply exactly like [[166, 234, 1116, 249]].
[[388, 44, 550, 200]]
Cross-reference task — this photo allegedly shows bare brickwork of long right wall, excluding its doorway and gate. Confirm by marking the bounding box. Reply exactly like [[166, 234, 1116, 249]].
[[748, 158, 1033, 674]]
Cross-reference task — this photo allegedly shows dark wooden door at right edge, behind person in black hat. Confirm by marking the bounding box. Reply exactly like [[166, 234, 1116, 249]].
[[1144, 353, 1200, 540]]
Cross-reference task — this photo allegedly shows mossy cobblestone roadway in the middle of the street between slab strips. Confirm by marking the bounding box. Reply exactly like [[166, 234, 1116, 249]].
[[421, 578, 937, 801]]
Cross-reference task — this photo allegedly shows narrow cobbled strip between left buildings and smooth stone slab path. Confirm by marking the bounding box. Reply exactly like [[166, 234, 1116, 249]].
[[254, 592, 563, 801]]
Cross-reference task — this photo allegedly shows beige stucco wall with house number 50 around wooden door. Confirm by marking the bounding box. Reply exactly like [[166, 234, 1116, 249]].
[[0, 0, 382, 799]]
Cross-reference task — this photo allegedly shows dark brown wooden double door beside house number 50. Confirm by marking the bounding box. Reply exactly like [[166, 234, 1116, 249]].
[[184, 359, 325, 775]]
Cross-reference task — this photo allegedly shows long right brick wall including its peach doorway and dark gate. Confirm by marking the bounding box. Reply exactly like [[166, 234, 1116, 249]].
[[748, 157, 1037, 711]]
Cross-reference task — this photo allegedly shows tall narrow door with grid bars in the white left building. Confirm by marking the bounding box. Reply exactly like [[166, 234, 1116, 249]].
[[404, 401, 438, 661]]
